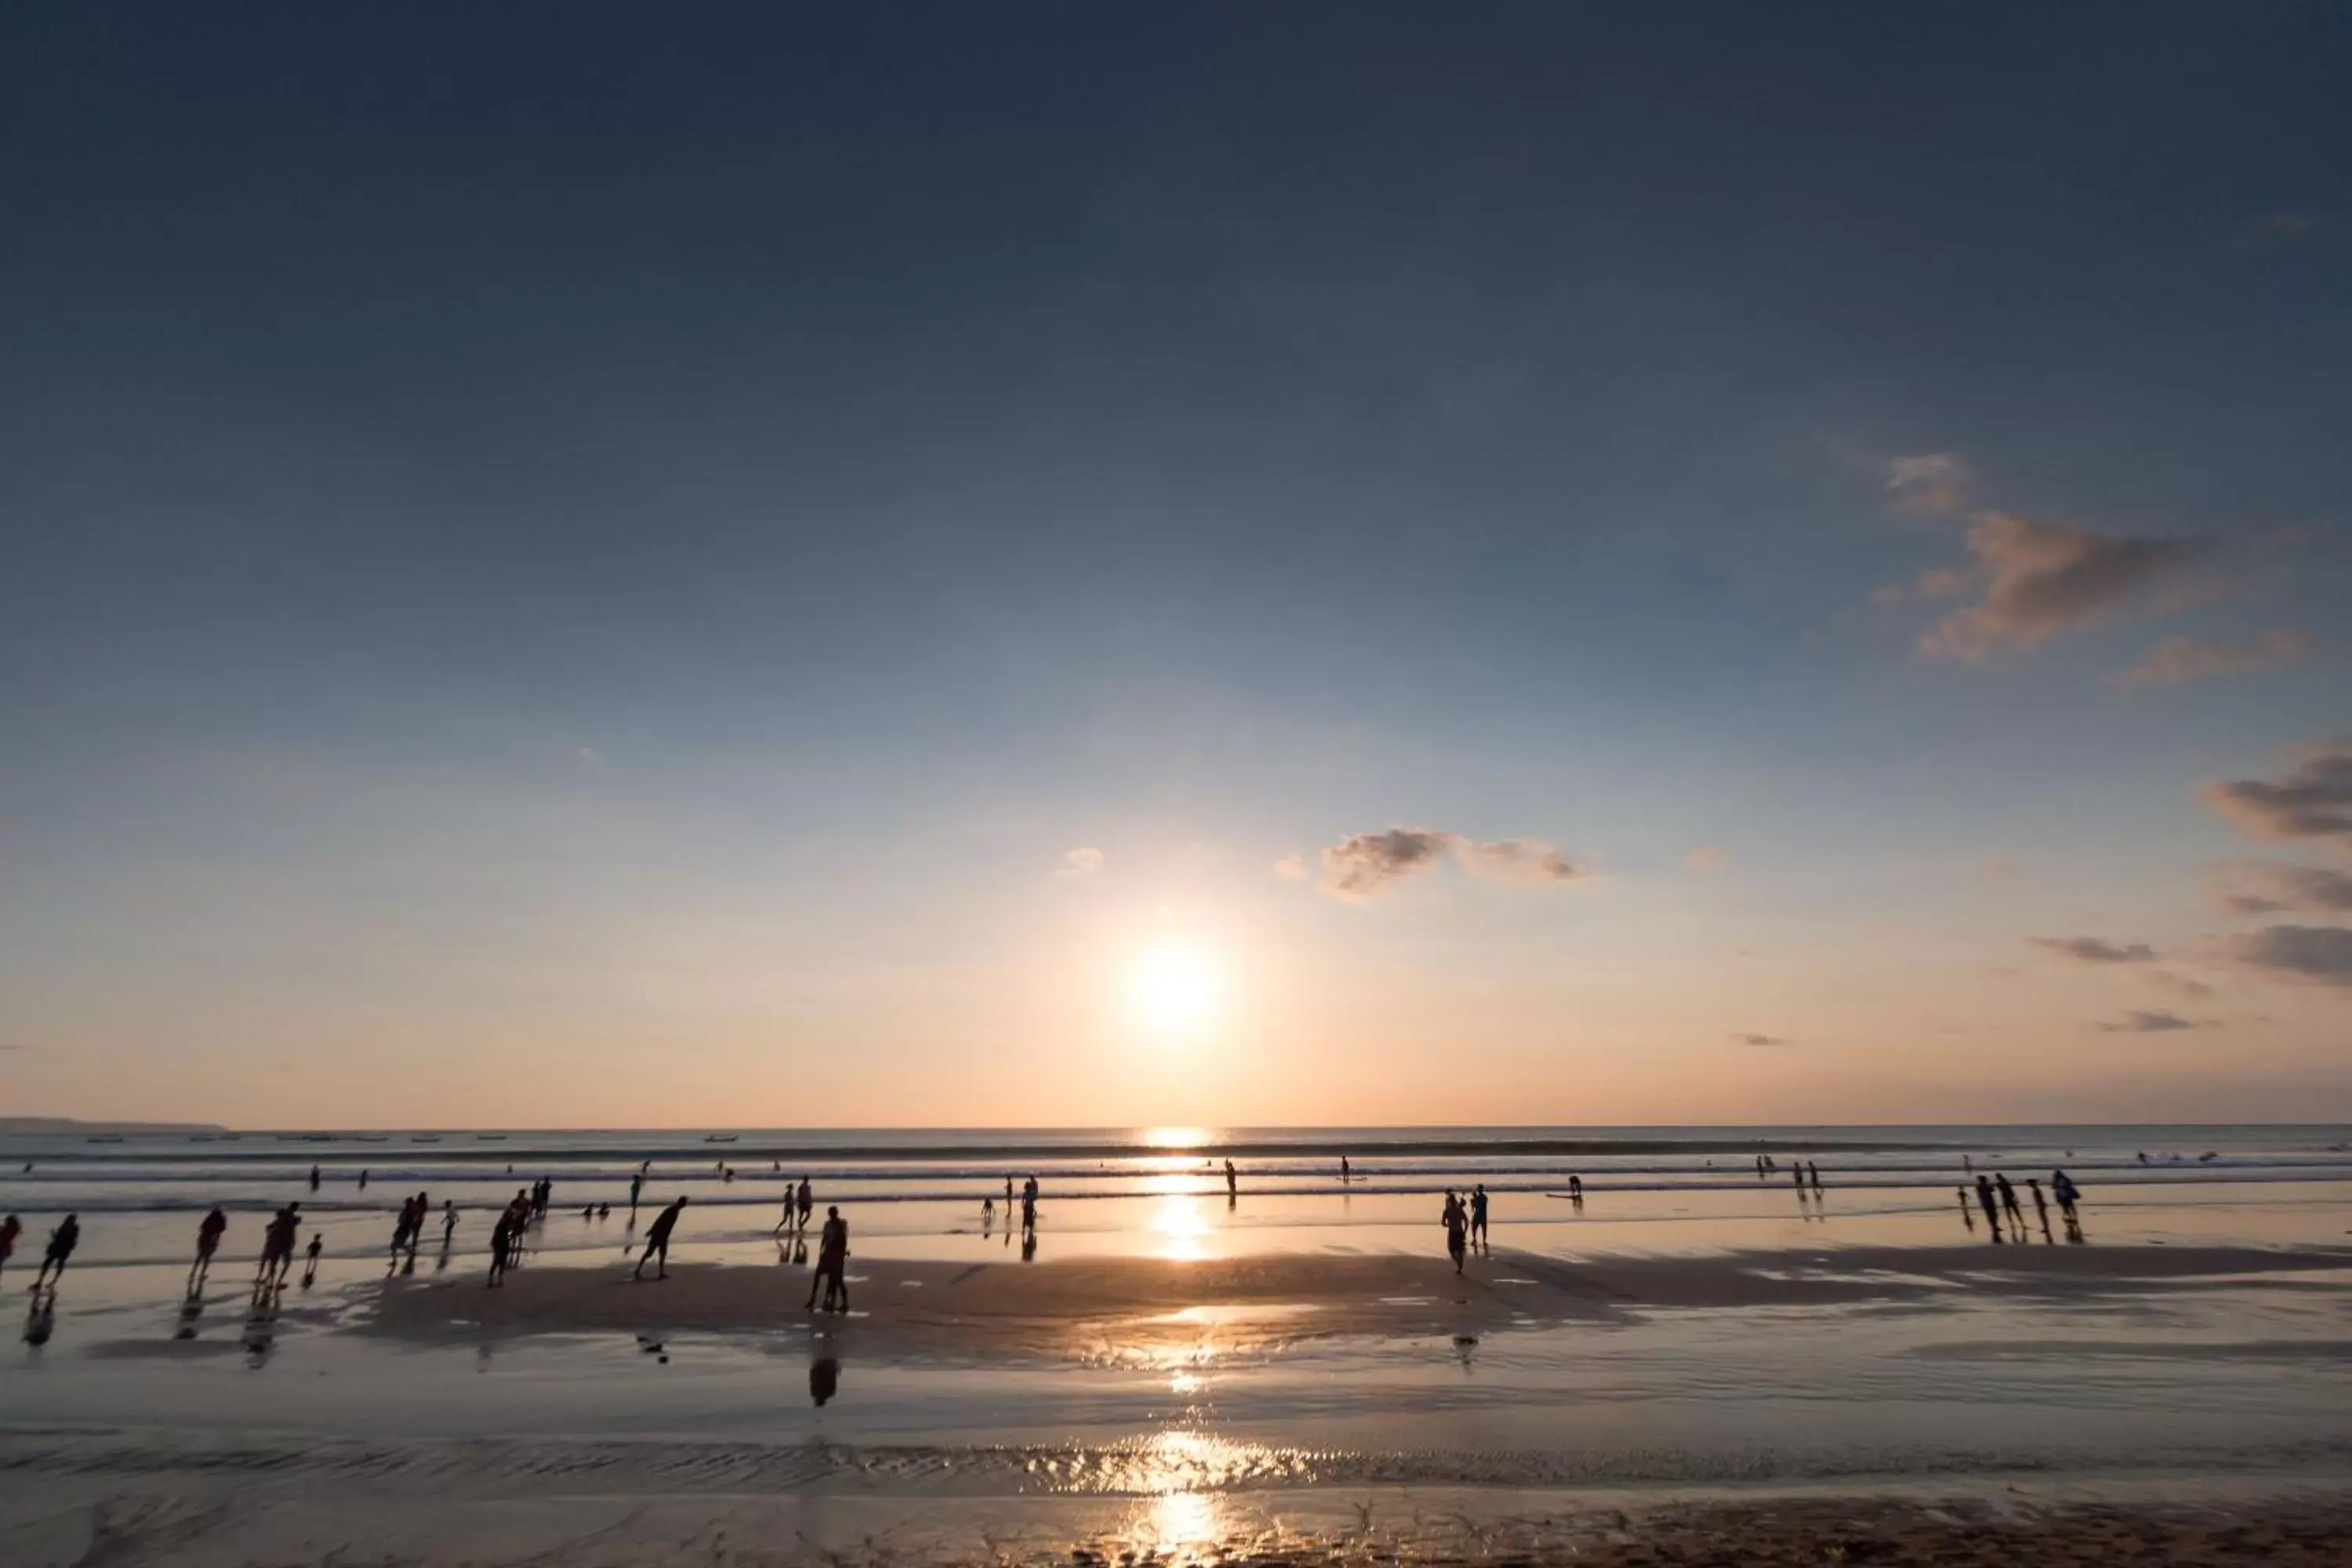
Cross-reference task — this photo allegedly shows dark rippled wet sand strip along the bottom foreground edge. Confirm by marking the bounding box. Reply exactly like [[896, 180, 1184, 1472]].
[[0, 1481, 2352, 1568]]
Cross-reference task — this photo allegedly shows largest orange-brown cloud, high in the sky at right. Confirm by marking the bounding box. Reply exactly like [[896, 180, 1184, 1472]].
[[1919, 513, 2197, 666]]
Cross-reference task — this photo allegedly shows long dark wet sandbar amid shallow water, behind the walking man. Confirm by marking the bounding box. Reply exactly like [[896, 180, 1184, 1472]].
[[360, 1246, 2352, 1361]]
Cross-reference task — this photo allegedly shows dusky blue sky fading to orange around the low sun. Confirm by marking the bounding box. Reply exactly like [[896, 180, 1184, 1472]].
[[0, 0, 2352, 1126]]
